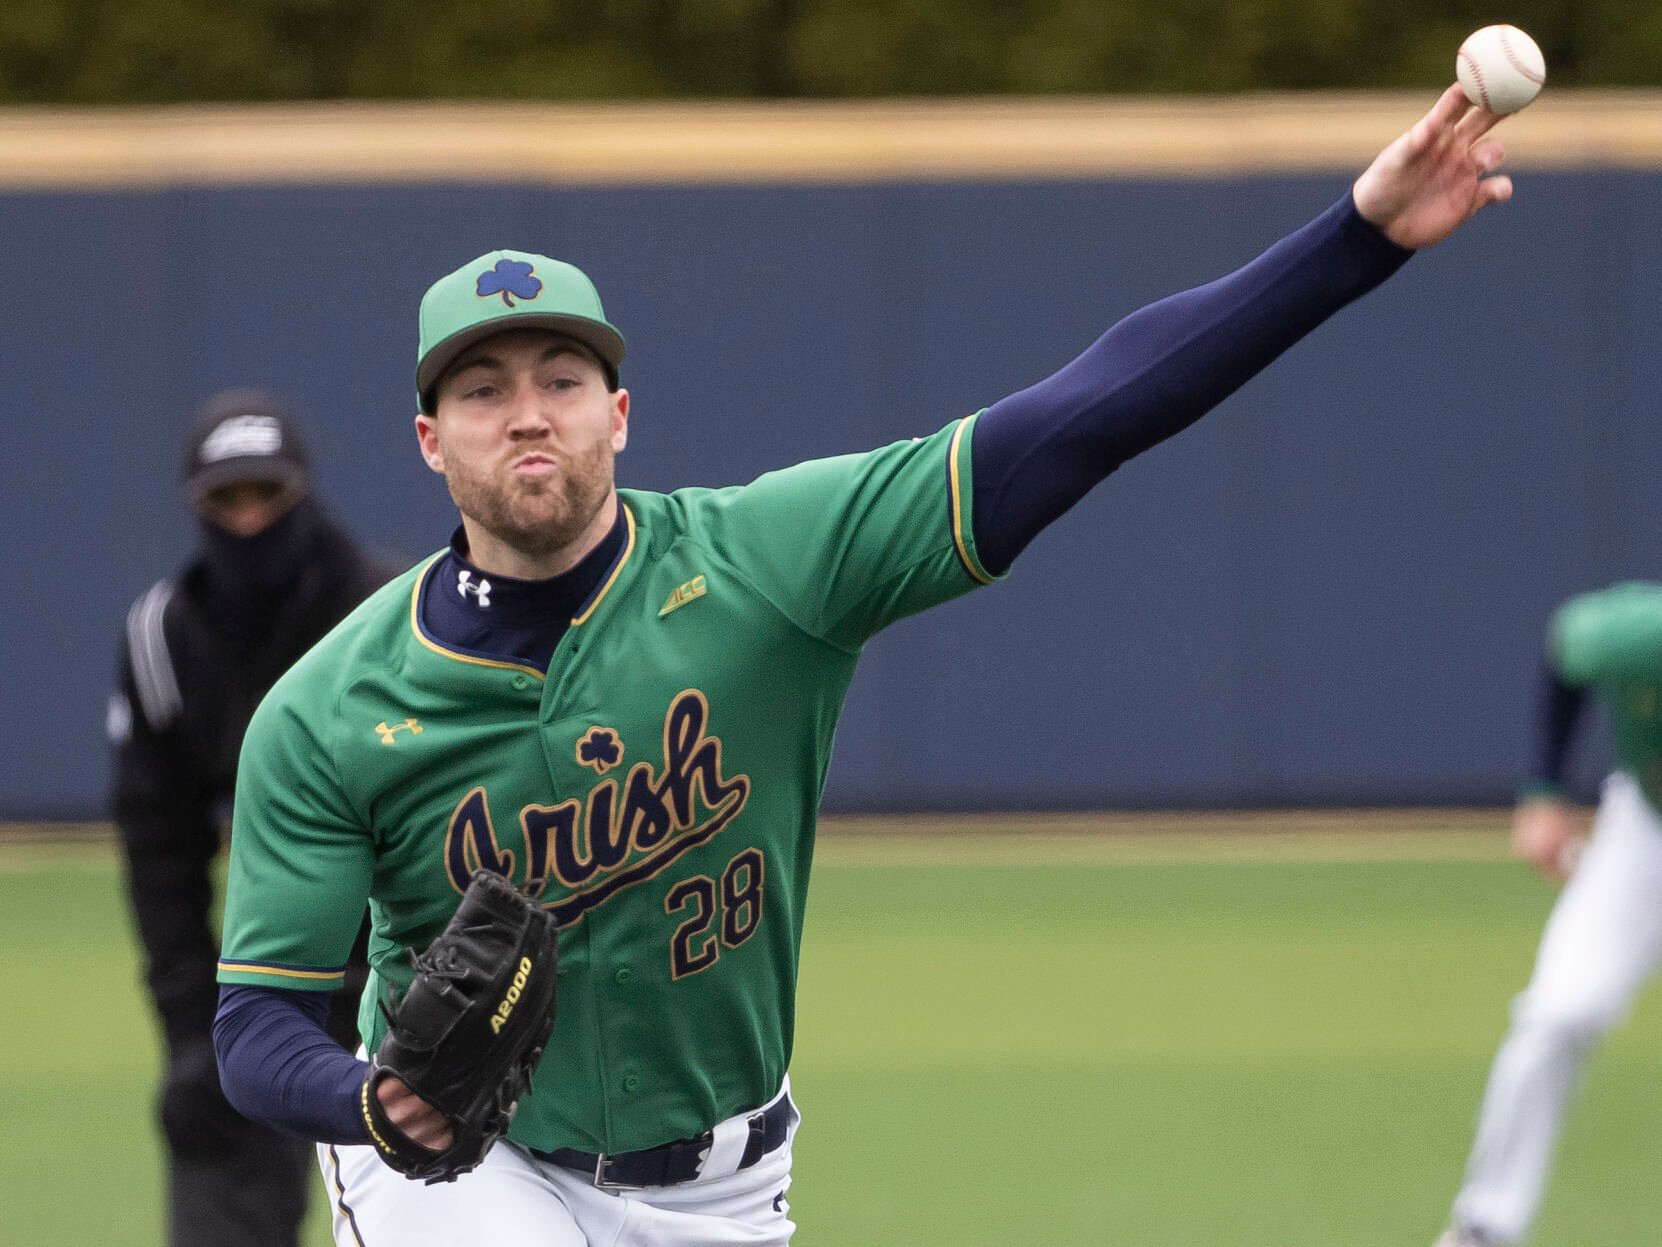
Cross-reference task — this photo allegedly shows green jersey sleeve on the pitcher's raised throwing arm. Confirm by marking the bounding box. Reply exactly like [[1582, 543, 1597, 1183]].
[[681, 416, 999, 652]]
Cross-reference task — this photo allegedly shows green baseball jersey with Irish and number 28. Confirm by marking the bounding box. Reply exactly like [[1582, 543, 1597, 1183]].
[[219, 417, 994, 1152]]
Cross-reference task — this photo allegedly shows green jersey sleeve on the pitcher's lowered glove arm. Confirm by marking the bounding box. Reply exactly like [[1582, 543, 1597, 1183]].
[[219, 660, 374, 991]]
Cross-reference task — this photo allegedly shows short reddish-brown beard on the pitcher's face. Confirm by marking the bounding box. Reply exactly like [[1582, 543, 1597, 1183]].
[[444, 442, 612, 559]]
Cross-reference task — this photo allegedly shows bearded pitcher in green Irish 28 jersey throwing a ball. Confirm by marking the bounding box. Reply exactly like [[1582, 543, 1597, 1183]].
[[214, 88, 1511, 1247]]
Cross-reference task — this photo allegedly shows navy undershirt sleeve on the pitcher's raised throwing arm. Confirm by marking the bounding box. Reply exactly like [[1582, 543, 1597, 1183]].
[[971, 193, 1413, 575]]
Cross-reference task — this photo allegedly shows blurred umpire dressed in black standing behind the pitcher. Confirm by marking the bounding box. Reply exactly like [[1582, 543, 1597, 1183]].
[[108, 389, 396, 1247]]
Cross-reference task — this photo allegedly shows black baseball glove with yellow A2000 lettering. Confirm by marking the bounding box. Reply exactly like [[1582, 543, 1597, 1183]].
[[361, 871, 555, 1182]]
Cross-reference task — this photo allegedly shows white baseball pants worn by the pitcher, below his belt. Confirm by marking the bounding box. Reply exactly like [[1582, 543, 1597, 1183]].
[[317, 1092, 796, 1247]]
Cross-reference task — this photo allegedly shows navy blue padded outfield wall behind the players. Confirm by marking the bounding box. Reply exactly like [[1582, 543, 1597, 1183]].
[[0, 173, 1642, 818]]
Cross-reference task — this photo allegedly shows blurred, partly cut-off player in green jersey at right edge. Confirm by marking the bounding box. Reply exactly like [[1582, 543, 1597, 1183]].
[[1438, 584, 1662, 1247]]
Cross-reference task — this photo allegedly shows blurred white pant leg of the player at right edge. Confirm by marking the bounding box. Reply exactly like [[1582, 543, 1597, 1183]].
[[1454, 771, 1662, 1242]]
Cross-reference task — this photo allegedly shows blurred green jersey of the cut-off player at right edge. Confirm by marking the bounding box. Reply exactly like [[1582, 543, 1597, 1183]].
[[1549, 584, 1662, 810]]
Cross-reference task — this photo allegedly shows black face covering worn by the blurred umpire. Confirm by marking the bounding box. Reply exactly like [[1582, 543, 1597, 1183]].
[[196, 497, 322, 645]]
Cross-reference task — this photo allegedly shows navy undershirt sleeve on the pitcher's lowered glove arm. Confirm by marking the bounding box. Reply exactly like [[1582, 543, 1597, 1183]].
[[213, 984, 369, 1144]]
